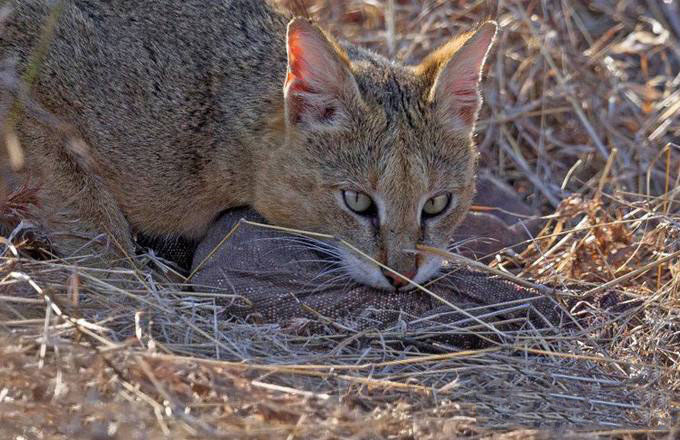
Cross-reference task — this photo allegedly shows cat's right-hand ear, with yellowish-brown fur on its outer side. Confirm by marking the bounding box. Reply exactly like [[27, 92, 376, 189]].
[[416, 21, 497, 132]]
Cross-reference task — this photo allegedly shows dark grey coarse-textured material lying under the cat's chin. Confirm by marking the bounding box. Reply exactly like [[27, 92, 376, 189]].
[[192, 182, 564, 347]]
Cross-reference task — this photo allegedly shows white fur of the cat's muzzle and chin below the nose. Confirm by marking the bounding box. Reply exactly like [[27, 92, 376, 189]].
[[342, 252, 443, 292]]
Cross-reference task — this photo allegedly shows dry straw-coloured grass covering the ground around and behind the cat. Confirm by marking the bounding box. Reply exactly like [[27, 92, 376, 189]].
[[0, 0, 680, 439]]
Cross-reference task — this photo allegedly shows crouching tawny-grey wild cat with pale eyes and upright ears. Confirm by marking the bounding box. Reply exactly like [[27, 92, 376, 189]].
[[0, 0, 497, 289]]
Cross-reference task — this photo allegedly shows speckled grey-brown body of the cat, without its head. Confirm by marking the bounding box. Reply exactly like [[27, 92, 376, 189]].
[[2, 0, 289, 240]]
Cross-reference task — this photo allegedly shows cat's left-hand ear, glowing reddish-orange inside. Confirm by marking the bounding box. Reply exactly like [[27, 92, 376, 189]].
[[283, 18, 359, 128]]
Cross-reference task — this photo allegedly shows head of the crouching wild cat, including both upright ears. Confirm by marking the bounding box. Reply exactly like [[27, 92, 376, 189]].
[[255, 20, 495, 289]]
